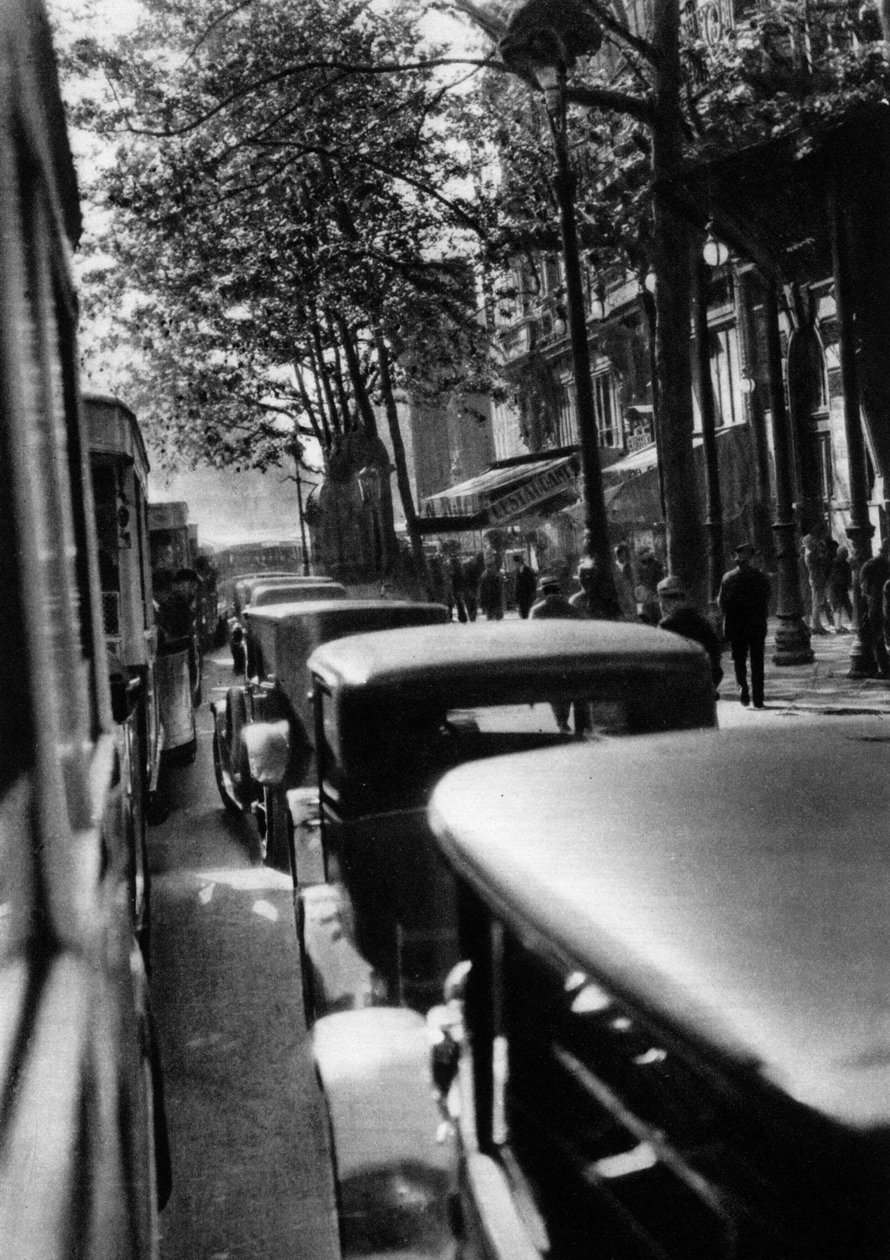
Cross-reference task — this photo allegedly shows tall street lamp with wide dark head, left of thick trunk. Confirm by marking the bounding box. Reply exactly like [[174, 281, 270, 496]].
[[500, 14, 618, 609]]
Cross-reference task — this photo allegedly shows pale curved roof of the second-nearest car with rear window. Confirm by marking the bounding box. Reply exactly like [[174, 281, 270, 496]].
[[309, 620, 705, 687]]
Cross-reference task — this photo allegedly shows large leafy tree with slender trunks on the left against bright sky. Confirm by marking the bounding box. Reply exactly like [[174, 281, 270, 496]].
[[67, 0, 499, 582]]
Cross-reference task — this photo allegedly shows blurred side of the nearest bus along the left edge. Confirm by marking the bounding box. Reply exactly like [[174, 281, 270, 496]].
[[0, 0, 168, 1260]]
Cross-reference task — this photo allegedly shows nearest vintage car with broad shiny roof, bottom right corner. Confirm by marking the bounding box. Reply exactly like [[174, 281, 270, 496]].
[[405, 719, 890, 1260]]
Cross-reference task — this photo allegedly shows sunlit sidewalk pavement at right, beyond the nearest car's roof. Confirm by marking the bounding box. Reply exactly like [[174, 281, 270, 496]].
[[720, 622, 890, 717]]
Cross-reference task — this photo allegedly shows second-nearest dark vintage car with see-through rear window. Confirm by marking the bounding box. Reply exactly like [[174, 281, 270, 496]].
[[301, 621, 716, 1014]]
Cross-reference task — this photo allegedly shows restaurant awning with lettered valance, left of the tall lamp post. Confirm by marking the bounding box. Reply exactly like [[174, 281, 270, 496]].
[[421, 455, 579, 533]]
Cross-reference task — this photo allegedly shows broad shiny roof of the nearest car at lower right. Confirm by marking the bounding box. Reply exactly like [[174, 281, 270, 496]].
[[430, 719, 890, 1129]]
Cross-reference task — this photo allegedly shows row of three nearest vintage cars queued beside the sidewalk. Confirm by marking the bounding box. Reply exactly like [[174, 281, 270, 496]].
[[214, 580, 890, 1260]]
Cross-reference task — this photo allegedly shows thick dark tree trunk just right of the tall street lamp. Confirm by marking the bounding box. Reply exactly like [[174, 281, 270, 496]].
[[652, 0, 707, 607]]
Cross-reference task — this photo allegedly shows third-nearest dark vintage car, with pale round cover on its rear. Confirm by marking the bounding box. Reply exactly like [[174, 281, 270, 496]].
[[212, 597, 448, 868]]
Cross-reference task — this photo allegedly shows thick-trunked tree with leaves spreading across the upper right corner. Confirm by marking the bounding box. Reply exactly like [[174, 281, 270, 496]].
[[449, 0, 887, 595]]
